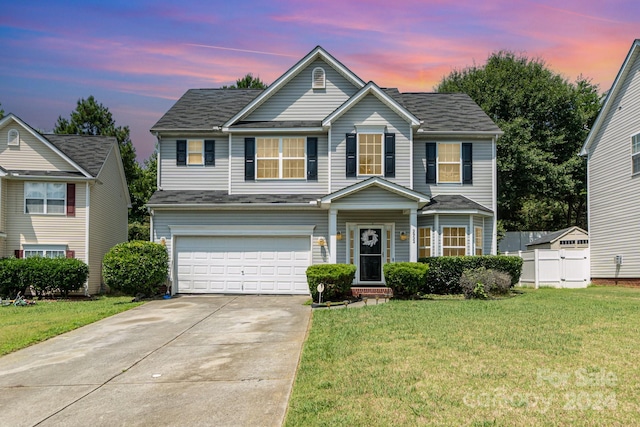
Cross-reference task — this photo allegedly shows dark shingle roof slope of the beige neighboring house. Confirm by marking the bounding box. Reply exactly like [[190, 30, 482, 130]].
[[42, 134, 117, 177]]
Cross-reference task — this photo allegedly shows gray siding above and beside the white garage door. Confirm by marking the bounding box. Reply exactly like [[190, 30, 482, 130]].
[[152, 209, 329, 264]]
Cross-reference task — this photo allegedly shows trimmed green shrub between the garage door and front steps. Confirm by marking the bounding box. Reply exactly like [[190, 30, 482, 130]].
[[307, 264, 356, 301]]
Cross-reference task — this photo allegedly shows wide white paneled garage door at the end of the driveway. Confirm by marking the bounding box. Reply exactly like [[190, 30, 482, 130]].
[[176, 236, 311, 294]]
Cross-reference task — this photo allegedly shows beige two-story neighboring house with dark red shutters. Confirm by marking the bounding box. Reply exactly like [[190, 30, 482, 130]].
[[0, 114, 130, 294]]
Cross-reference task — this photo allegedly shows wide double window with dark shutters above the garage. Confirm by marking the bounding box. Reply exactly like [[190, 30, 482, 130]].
[[256, 137, 306, 179]]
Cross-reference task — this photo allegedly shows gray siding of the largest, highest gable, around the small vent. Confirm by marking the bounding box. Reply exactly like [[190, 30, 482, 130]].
[[244, 59, 358, 121]]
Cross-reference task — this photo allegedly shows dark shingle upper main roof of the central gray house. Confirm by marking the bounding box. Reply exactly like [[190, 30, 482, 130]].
[[151, 88, 500, 132]]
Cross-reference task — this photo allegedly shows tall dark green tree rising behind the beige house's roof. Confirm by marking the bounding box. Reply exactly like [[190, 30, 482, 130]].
[[53, 95, 139, 186]]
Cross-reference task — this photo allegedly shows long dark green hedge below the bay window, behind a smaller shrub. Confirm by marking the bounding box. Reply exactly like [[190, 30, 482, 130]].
[[418, 255, 522, 294]]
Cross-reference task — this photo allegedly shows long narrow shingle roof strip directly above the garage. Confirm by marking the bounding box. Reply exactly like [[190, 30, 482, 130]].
[[147, 190, 322, 205]]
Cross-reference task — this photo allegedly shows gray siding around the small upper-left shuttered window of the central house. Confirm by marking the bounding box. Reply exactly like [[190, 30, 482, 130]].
[[159, 134, 229, 191]]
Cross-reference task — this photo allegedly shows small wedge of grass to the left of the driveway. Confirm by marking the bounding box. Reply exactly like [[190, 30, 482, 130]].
[[0, 297, 141, 356]]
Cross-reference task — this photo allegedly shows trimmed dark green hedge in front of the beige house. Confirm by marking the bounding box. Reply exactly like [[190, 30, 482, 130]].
[[0, 257, 89, 298]]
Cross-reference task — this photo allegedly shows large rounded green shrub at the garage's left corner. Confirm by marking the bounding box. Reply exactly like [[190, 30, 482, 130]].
[[102, 241, 169, 296]]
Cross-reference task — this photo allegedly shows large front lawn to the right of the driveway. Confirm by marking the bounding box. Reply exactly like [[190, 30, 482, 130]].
[[285, 287, 640, 426]]
